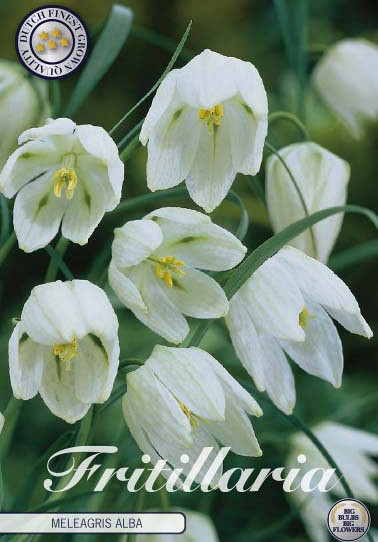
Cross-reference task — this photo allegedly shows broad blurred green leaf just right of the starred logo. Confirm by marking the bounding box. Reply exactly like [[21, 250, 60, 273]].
[[65, 4, 133, 117]]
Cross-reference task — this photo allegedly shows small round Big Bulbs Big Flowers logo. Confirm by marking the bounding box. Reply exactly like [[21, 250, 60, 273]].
[[327, 499, 370, 540]]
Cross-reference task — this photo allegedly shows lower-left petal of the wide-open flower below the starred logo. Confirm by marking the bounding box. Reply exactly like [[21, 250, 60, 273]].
[[13, 172, 67, 252]]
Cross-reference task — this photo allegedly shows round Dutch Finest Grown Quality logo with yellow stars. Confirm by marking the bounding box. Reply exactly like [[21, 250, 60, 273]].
[[16, 6, 89, 79]]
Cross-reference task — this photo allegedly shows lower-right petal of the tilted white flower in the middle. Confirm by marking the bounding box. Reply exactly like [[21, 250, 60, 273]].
[[167, 266, 228, 318]]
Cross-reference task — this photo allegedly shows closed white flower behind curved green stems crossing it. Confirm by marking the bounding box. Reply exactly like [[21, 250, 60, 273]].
[[266, 142, 350, 262]]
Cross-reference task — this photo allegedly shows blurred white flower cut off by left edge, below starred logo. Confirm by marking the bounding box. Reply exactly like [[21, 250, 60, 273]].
[[0, 60, 50, 168]]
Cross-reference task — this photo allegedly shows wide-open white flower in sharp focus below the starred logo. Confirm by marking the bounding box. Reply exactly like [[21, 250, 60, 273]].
[[0, 118, 124, 252]]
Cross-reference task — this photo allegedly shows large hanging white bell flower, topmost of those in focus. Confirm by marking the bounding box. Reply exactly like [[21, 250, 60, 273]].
[[140, 49, 268, 212]]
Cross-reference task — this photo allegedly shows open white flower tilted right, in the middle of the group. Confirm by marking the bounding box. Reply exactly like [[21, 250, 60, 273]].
[[109, 207, 246, 343]]
